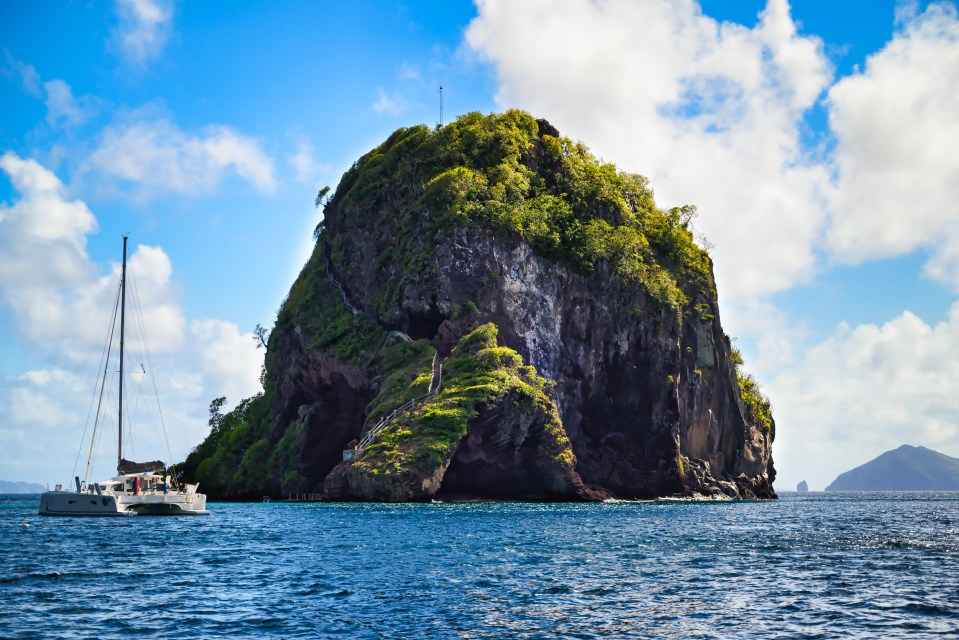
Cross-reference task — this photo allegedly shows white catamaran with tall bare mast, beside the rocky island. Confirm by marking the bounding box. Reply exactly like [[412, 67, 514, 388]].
[[40, 236, 210, 516]]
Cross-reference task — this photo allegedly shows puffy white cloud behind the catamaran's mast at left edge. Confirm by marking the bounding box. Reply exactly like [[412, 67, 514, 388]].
[[0, 152, 184, 361]]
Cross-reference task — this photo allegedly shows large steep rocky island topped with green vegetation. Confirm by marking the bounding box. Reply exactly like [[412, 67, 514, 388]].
[[180, 111, 776, 501]]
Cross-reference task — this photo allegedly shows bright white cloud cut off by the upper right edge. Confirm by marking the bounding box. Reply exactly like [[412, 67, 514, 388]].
[[828, 4, 959, 292]]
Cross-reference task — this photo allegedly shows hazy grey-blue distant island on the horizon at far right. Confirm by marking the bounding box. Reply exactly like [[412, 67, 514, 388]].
[[826, 444, 959, 491]]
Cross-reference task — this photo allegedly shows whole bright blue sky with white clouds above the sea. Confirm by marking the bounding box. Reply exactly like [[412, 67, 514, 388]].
[[0, 0, 959, 489]]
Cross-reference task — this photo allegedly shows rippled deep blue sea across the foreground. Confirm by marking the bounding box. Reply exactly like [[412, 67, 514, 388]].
[[0, 493, 959, 639]]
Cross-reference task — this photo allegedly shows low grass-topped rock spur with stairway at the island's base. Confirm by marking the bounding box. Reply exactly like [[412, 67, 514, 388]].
[[324, 324, 593, 501]]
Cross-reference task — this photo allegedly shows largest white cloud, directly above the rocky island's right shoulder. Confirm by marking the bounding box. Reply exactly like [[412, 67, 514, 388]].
[[466, 0, 831, 299]]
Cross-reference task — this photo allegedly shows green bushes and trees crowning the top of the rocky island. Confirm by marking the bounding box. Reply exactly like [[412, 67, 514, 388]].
[[330, 110, 713, 310]]
